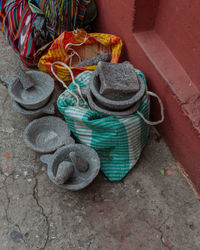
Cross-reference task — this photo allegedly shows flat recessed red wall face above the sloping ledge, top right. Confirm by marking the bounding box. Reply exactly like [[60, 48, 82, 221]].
[[155, 0, 200, 88]]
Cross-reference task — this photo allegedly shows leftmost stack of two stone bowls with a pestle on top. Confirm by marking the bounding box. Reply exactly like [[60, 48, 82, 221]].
[[4, 67, 55, 118]]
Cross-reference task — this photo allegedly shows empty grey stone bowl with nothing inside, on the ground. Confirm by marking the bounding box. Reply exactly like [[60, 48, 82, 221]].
[[24, 116, 74, 153]]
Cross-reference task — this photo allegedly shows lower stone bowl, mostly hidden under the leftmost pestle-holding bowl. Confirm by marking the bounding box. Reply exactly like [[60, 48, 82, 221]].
[[11, 93, 56, 119]]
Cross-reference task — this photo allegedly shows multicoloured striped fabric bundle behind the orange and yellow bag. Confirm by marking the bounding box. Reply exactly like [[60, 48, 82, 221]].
[[0, 0, 94, 67]]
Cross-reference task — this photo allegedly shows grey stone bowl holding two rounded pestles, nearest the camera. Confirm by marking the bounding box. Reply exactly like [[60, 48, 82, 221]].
[[40, 144, 100, 191]]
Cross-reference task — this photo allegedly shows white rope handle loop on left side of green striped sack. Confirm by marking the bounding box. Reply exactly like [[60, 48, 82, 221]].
[[51, 62, 85, 106]]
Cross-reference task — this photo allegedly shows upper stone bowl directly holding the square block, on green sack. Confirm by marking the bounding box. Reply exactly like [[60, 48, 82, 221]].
[[89, 70, 146, 111]]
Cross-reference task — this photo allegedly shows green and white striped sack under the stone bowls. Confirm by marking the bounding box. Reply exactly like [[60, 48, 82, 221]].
[[56, 70, 164, 181]]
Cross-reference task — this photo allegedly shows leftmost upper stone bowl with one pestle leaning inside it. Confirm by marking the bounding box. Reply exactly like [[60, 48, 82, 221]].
[[8, 71, 54, 110]]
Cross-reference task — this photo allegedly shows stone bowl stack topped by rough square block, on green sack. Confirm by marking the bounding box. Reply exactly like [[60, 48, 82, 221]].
[[87, 62, 146, 116]]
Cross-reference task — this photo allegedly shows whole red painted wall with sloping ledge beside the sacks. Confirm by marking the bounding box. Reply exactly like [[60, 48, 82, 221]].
[[96, 0, 200, 191]]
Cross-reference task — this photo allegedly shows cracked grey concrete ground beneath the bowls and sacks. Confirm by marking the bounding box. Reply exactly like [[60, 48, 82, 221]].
[[0, 34, 200, 250]]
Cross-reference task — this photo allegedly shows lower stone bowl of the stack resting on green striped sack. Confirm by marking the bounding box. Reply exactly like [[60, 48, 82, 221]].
[[87, 91, 142, 116]]
